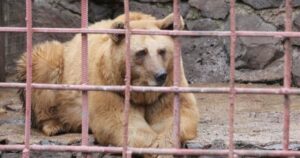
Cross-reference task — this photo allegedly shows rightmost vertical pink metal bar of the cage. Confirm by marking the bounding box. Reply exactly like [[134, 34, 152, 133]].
[[282, 0, 293, 150]]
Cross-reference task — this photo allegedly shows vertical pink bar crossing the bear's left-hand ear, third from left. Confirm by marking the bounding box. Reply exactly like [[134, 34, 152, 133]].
[[122, 0, 131, 158]]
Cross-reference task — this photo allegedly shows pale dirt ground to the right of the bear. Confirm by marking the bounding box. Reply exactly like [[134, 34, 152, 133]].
[[193, 84, 300, 150]]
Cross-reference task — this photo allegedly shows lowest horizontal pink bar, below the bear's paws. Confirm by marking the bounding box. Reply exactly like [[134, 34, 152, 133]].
[[0, 145, 300, 157]]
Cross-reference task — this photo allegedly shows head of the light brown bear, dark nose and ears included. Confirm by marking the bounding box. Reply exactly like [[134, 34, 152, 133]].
[[110, 13, 184, 104]]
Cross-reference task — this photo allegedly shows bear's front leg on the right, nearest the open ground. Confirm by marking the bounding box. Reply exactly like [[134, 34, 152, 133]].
[[146, 93, 199, 148]]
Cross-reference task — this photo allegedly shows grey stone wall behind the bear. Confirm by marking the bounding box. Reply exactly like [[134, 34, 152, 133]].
[[3, 0, 300, 86]]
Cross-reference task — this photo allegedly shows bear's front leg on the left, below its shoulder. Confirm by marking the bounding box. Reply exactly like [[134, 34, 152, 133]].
[[89, 92, 157, 148]]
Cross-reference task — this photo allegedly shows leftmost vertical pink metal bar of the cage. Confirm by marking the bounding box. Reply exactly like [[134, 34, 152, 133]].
[[22, 0, 32, 158]]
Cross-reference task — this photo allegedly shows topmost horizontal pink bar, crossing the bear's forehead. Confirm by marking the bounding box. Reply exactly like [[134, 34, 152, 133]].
[[0, 27, 300, 38]]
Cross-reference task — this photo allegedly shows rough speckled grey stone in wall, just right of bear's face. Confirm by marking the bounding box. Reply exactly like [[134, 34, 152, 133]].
[[181, 37, 229, 83]]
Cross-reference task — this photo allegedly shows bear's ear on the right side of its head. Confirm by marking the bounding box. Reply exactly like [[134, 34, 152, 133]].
[[156, 13, 184, 30]]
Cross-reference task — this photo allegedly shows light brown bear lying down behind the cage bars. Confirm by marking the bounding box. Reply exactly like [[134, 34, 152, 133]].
[[17, 12, 199, 153]]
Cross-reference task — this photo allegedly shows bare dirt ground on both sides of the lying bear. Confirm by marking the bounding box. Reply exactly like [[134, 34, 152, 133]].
[[0, 84, 300, 150]]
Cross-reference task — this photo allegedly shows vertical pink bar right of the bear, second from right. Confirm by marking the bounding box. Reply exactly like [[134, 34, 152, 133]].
[[228, 0, 237, 158]]
